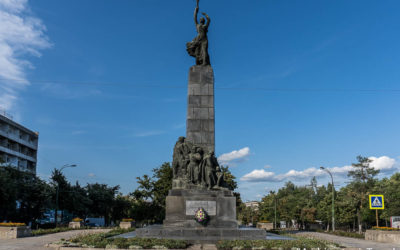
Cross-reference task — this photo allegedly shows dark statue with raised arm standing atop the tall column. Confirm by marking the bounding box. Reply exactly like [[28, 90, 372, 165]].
[[186, 0, 211, 66]]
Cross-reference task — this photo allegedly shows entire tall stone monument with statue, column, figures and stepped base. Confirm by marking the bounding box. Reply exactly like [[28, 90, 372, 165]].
[[136, 0, 266, 243]]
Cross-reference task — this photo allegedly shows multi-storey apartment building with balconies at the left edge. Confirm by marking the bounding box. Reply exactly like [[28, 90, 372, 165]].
[[0, 112, 39, 174]]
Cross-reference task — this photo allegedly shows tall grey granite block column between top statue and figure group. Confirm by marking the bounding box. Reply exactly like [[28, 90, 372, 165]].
[[186, 65, 215, 151]]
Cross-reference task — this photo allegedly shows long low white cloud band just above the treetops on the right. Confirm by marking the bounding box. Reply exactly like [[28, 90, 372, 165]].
[[240, 156, 398, 182]]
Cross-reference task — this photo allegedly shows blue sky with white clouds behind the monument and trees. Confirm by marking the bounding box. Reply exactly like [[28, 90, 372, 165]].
[[0, 0, 400, 200]]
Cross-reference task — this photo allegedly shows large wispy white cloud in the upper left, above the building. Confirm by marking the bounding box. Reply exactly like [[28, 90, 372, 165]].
[[0, 0, 51, 109]]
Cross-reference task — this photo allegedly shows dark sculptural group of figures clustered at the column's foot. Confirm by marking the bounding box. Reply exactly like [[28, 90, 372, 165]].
[[172, 137, 225, 189]]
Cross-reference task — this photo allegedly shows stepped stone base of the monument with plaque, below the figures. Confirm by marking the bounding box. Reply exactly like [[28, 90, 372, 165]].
[[136, 189, 266, 243]]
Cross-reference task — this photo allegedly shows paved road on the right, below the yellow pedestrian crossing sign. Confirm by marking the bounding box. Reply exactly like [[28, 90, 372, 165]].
[[295, 232, 400, 250]]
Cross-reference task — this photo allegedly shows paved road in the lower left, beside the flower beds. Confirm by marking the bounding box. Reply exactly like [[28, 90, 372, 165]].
[[0, 229, 110, 250]]
